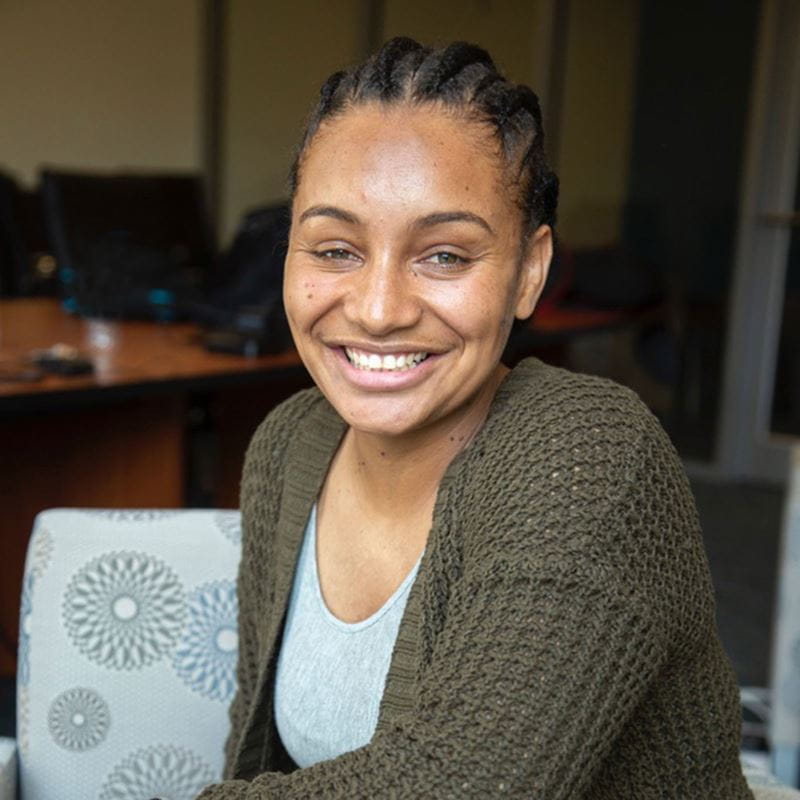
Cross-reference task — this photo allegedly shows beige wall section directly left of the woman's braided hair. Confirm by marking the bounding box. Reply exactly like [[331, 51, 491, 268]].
[[220, 0, 363, 240]]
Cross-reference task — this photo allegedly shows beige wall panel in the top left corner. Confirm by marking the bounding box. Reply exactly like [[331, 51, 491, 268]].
[[0, 0, 203, 184]]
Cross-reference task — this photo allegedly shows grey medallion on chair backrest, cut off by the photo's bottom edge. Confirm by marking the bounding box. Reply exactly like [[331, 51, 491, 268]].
[[99, 745, 214, 800]]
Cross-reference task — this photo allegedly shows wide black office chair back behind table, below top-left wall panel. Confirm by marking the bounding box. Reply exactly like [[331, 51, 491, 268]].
[[41, 169, 215, 319]]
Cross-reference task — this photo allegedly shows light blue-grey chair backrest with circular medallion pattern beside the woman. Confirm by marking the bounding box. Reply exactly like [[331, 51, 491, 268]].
[[17, 509, 240, 800]]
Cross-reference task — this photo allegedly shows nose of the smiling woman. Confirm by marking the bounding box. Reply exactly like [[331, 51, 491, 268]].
[[345, 256, 421, 336]]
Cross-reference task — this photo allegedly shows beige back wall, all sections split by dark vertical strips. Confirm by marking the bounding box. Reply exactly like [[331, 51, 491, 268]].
[[0, 0, 638, 246]]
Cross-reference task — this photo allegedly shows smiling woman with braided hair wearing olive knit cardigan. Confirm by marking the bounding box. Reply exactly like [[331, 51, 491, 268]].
[[202, 39, 751, 800]]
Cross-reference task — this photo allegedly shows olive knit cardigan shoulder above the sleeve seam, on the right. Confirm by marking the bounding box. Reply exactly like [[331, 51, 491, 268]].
[[456, 361, 711, 636]]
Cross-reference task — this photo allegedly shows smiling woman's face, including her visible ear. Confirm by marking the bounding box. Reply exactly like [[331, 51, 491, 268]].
[[284, 106, 551, 435]]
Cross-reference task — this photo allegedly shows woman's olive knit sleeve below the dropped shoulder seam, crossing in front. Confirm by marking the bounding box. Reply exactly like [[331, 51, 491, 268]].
[[201, 563, 667, 800]]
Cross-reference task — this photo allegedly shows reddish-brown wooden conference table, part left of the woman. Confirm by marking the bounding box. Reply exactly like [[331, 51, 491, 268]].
[[0, 298, 308, 675]]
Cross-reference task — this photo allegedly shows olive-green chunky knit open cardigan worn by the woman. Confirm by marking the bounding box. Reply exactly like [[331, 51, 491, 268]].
[[200, 359, 752, 800]]
